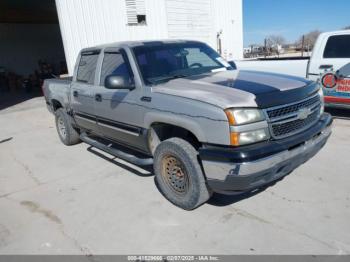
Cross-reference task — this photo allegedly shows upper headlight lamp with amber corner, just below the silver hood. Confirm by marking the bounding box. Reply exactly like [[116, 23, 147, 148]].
[[225, 108, 264, 126]]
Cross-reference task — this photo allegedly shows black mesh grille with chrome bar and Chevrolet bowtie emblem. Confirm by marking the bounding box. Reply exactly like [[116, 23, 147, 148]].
[[265, 95, 321, 139]]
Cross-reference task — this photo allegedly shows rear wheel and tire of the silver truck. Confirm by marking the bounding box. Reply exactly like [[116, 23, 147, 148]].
[[55, 108, 80, 146]]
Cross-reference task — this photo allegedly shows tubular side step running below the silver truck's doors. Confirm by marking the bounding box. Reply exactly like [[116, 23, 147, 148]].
[[80, 133, 153, 166]]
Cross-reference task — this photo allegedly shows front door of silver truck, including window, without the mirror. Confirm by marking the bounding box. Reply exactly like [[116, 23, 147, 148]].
[[95, 49, 147, 151]]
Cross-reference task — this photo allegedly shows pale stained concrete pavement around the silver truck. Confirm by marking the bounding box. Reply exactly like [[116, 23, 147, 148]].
[[0, 98, 350, 255]]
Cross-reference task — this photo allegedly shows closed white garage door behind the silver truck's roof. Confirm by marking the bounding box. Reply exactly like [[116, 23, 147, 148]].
[[166, 0, 215, 43]]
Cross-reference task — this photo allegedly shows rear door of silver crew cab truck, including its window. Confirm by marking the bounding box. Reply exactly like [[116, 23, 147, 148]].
[[70, 50, 100, 132]]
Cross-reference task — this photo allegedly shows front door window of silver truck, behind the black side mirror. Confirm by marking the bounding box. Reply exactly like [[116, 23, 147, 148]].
[[100, 50, 133, 85]]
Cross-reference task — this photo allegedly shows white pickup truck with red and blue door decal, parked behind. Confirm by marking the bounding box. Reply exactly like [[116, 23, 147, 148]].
[[237, 30, 350, 108]]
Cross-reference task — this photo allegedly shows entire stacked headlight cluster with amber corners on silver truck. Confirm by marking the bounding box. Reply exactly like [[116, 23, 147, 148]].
[[225, 108, 270, 146]]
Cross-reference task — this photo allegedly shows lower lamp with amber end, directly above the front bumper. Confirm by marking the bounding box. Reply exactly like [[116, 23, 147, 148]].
[[230, 128, 270, 146]]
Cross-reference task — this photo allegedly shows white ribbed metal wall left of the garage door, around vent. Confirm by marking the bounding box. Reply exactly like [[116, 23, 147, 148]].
[[56, 0, 168, 74]]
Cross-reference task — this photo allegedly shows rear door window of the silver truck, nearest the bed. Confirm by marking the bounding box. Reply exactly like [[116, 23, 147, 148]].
[[77, 53, 99, 85]]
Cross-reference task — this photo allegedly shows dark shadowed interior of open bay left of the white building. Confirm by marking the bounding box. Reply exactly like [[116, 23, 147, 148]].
[[0, 24, 65, 76]]
